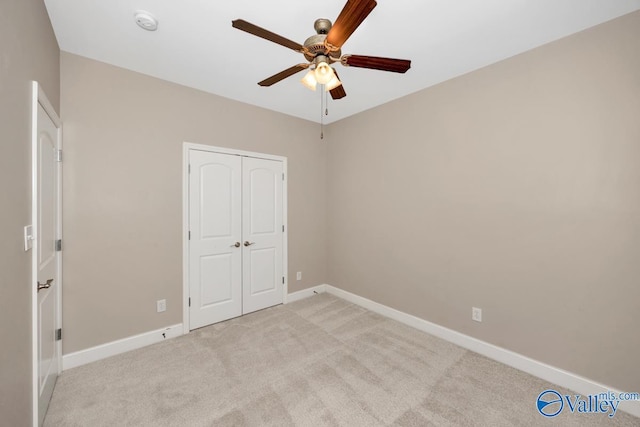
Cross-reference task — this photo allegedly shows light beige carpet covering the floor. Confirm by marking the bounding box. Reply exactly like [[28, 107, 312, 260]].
[[45, 294, 640, 427]]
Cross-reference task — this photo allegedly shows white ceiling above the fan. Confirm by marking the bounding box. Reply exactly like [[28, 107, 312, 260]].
[[45, 0, 640, 123]]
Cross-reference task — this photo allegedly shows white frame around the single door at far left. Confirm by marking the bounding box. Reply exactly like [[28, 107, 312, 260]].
[[30, 81, 62, 426]]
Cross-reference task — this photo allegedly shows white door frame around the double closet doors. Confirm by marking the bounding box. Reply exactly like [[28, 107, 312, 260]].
[[182, 142, 289, 334]]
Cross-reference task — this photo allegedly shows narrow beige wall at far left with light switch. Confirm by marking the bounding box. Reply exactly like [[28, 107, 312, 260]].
[[0, 0, 60, 426]]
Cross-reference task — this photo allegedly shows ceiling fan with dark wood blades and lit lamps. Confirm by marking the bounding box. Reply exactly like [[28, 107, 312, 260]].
[[231, 0, 411, 99]]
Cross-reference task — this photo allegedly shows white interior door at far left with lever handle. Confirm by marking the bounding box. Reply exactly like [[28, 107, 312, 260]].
[[32, 85, 61, 425]]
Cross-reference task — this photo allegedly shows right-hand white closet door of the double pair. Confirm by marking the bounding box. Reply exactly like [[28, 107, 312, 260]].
[[242, 157, 284, 314]]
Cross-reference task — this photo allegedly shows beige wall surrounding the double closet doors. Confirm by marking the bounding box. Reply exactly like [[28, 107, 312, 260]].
[[61, 53, 326, 354]]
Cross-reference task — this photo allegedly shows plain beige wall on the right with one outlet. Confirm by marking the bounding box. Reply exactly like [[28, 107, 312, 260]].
[[327, 13, 640, 390]]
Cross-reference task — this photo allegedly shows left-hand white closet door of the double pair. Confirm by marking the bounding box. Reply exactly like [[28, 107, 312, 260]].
[[189, 150, 243, 329]]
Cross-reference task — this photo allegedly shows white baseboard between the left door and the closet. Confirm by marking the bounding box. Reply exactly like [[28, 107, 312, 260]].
[[62, 323, 183, 371]]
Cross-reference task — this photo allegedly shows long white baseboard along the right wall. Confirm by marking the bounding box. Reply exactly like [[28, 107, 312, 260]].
[[323, 285, 640, 417]]
